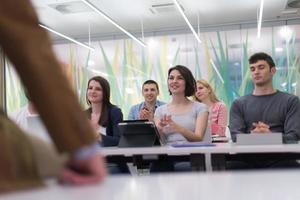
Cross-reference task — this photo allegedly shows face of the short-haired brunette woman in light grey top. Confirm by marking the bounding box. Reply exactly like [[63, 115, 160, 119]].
[[168, 69, 186, 95]]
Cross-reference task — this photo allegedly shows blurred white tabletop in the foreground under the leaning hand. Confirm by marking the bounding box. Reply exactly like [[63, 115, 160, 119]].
[[0, 170, 300, 200]]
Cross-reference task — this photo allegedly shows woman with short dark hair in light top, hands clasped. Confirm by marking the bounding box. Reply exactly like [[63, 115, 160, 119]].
[[155, 65, 210, 143]]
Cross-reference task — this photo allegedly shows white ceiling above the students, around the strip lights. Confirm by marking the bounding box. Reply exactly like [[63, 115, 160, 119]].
[[32, 0, 300, 39]]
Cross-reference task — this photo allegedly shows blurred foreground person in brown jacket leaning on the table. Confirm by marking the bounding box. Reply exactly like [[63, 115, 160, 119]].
[[0, 0, 106, 193]]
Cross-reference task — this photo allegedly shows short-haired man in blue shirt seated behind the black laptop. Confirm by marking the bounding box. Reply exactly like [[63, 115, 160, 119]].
[[128, 80, 165, 121]]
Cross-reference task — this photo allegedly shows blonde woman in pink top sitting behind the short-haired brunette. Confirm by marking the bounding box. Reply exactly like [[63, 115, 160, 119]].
[[194, 79, 227, 136]]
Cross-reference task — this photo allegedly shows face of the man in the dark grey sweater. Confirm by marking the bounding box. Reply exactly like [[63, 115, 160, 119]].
[[250, 60, 276, 86]]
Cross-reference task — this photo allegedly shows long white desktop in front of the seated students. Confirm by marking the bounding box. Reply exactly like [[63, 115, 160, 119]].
[[101, 143, 300, 156]]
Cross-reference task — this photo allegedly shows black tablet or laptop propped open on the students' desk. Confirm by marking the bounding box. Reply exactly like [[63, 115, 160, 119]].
[[118, 120, 166, 147]]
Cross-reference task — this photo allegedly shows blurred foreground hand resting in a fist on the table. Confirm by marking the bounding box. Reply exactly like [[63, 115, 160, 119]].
[[59, 154, 107, 185]]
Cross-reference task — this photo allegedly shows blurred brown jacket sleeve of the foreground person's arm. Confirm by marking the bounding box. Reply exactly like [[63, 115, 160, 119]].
[[0, 0, 94, 152]]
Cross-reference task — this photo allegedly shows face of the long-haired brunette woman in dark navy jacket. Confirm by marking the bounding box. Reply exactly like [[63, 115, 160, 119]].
[[87, 80, 103, 104]]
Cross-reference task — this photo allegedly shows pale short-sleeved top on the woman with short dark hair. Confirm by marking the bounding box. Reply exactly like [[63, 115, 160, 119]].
[[154, 101, 208, 143]]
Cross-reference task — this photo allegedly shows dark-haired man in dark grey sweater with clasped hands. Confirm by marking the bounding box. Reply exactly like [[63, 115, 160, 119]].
[[230, 53, 300, 168]]
